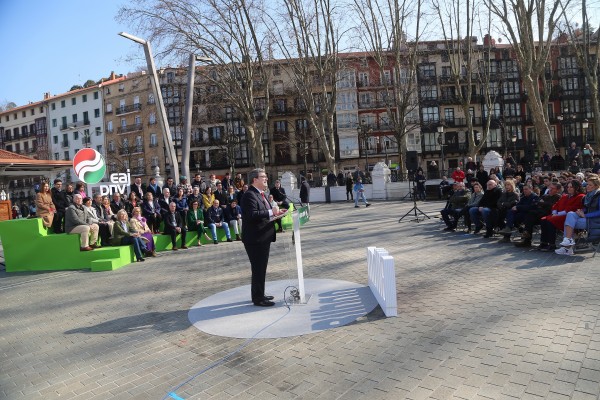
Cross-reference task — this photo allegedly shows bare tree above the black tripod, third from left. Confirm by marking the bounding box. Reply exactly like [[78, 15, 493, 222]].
[[354, 0, 425, 172]]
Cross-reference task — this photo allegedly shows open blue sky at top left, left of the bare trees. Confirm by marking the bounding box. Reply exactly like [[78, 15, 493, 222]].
[[0, 0, 145, 106]]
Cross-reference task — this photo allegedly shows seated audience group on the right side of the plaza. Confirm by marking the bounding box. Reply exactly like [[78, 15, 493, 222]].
[[441, 165, 600, 255]]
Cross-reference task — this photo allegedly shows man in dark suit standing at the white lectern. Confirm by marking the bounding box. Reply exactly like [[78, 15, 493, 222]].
[[241, 168, 285, 307]]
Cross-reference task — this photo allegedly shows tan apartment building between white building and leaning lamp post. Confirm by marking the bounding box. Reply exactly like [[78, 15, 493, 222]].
[[102, 72, 165, 182]]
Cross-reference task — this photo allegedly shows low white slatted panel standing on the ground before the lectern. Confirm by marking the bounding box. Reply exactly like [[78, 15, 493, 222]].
[[367, 247, 398, 317]]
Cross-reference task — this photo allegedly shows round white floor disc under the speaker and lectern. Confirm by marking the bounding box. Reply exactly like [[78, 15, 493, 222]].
[[188, 279, 377, 338]]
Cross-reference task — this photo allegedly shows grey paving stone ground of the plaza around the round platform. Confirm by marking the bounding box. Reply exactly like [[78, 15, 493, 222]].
[[0, 202, 600, 400]]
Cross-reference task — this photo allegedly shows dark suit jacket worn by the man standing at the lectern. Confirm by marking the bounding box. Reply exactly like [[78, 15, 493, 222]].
[[241, 186, 276, 244]]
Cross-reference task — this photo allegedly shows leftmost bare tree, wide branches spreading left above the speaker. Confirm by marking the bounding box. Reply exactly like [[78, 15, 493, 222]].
[[119, 0, 269, 166]]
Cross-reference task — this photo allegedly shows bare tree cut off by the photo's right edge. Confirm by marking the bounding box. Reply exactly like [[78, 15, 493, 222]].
[[561, 0, 600, 143]]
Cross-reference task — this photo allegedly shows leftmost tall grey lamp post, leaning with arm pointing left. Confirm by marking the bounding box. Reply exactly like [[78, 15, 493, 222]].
[[119, 32, 179, 182]]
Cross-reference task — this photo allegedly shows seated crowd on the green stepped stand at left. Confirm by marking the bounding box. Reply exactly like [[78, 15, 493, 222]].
[[30, 173, 298, 261]]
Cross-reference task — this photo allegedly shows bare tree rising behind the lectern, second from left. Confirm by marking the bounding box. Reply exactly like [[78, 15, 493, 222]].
[[272, 0, 343, 173]]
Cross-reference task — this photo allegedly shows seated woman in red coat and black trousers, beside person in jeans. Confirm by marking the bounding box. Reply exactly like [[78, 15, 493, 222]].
[[538, 180, 585, 251]]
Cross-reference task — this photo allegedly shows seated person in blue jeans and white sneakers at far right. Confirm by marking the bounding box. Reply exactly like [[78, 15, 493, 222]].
[[556, 175, 600, 256]]
